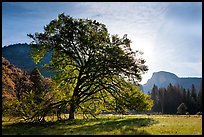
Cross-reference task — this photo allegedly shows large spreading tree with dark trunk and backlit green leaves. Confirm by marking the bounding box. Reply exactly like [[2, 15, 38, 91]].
[[28, 14, 151, 119]]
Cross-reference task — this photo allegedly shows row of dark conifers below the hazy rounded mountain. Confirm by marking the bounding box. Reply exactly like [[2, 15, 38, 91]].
[[149, 83, 202, 114]]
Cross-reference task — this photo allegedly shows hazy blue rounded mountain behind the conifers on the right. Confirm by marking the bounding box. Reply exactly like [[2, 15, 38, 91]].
[[141, 71, 202, 93]]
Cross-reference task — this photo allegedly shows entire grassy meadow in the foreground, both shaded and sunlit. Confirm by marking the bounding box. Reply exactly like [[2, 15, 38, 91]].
[[2, 115, 202, 135]]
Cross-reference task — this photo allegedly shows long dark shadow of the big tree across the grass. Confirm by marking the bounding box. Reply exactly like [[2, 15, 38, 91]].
[[2, 118, 158, 135]]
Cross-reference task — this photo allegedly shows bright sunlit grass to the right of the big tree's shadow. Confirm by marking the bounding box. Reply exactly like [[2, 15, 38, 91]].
[[139, 115, 202, 135]]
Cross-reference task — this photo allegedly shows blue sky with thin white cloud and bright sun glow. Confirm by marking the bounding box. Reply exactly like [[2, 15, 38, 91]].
[[2, 2, 202, 84]]
